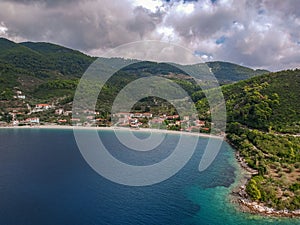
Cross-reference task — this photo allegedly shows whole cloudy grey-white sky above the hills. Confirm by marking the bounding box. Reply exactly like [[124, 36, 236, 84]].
[[0, 0, 300, 71]]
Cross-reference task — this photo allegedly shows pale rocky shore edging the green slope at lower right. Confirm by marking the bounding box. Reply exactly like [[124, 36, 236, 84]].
[[231, 151, 300, 217]]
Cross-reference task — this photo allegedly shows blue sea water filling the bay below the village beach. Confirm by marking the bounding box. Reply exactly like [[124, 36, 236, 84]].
[[0, 129, 300, 225]]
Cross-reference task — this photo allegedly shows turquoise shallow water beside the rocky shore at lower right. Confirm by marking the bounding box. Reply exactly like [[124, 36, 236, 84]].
[[185, 143, 300, 225]]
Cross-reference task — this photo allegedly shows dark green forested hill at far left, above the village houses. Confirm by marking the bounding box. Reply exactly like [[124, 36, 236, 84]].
[[0, 38, 95, 102]]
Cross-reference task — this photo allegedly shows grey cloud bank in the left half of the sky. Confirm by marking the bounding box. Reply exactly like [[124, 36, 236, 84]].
[[0, 0, 159, 51]]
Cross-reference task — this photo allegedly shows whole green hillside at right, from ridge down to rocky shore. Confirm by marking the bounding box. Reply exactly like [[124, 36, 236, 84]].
[[223, 70, 300, 210]]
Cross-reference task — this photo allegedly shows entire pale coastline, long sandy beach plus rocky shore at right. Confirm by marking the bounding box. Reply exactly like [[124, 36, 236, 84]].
[[0, 125, 300, 218]]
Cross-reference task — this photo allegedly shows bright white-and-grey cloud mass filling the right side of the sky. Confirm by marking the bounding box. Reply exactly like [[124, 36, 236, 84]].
[[159, 0, 300, 70]]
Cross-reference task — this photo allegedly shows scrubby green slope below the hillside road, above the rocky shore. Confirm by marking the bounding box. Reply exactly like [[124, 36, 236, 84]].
[[227, 123, 300, 210]]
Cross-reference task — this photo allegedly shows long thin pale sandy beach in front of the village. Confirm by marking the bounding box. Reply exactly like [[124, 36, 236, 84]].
[[0, 125, 225, 140]]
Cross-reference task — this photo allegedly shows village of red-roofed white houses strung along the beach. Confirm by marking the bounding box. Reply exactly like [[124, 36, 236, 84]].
[[0, 90, 210, 133]]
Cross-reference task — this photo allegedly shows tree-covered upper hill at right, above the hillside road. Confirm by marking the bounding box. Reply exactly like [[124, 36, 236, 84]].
[[223, 69, 300, 133]]
